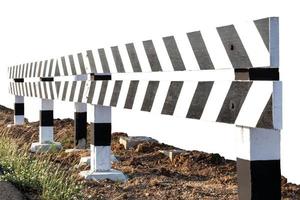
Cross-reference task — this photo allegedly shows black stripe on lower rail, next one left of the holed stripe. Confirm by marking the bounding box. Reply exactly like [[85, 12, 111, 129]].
[[186, 81, 214, 119]]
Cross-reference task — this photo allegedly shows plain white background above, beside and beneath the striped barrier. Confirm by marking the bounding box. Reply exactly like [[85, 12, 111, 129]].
[[0, 0, 300, 184]]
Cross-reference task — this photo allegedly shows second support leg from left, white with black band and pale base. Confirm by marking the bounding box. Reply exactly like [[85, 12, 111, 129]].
[[30, 99, 62, 152]]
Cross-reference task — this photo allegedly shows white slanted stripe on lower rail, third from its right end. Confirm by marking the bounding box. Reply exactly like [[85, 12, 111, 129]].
[[173, 81, 198, 117]]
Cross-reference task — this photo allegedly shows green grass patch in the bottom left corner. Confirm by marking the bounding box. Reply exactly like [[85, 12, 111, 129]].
[[0, 136, 83, 200]]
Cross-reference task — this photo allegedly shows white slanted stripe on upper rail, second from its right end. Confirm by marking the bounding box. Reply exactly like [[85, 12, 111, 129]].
[[201, 27, 232, 69]]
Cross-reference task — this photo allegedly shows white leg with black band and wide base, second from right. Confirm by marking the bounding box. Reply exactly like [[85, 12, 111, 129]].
[[80, 105, 126, 181]]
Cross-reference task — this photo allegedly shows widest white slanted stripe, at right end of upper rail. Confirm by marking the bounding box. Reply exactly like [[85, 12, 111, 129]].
[[234, 22, 270, 67]]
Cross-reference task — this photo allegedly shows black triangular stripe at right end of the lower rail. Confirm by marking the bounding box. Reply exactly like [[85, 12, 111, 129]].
[[256, 95, 274, 129]]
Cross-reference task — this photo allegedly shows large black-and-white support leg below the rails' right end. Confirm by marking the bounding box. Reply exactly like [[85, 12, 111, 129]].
[[237, 127, 281, 200]]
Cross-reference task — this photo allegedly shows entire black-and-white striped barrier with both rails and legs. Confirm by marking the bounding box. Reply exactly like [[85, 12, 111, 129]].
[[9, 17, 282, 199]]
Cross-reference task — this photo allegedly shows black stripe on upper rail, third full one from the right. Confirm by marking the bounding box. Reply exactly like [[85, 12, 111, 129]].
[[163, 36, 185, 71]]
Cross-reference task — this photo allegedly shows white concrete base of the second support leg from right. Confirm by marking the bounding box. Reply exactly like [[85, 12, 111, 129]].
[[79, 169, 127, 182]]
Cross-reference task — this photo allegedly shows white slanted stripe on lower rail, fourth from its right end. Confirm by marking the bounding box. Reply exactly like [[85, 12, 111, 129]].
[[151, 81, 171, 114]]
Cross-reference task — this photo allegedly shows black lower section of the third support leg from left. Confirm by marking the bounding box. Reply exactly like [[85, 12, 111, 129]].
[[74, 112, 87, 146]]
